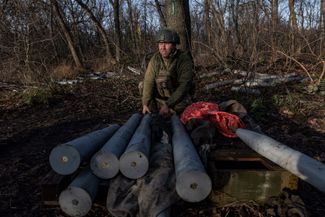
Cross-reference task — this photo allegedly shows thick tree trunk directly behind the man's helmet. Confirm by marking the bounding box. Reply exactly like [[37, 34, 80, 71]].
[[166, 0, 191, 51]]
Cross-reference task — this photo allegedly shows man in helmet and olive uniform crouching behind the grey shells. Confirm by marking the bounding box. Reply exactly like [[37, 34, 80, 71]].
[[142, 29, 194, 117]]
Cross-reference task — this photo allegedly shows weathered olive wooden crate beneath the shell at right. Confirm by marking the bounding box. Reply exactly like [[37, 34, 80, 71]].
[[208, 150, 298, 206]]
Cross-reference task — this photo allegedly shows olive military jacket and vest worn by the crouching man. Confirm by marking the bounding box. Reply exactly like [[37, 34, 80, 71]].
[[142, 50, 194, 113]]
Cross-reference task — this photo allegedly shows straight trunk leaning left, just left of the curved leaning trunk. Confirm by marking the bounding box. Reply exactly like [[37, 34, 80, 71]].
[[51, 0, 83, 68]]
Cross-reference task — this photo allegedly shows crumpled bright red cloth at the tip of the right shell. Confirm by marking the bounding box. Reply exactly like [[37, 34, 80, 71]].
[[181, 102, 245, 138]]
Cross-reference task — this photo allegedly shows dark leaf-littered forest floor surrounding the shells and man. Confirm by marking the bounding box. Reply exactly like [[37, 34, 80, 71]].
[[0, 66, 325, 217]]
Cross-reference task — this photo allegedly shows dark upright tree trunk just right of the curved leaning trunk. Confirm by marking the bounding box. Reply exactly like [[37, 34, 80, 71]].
[[110, 0, 122, 62]]
